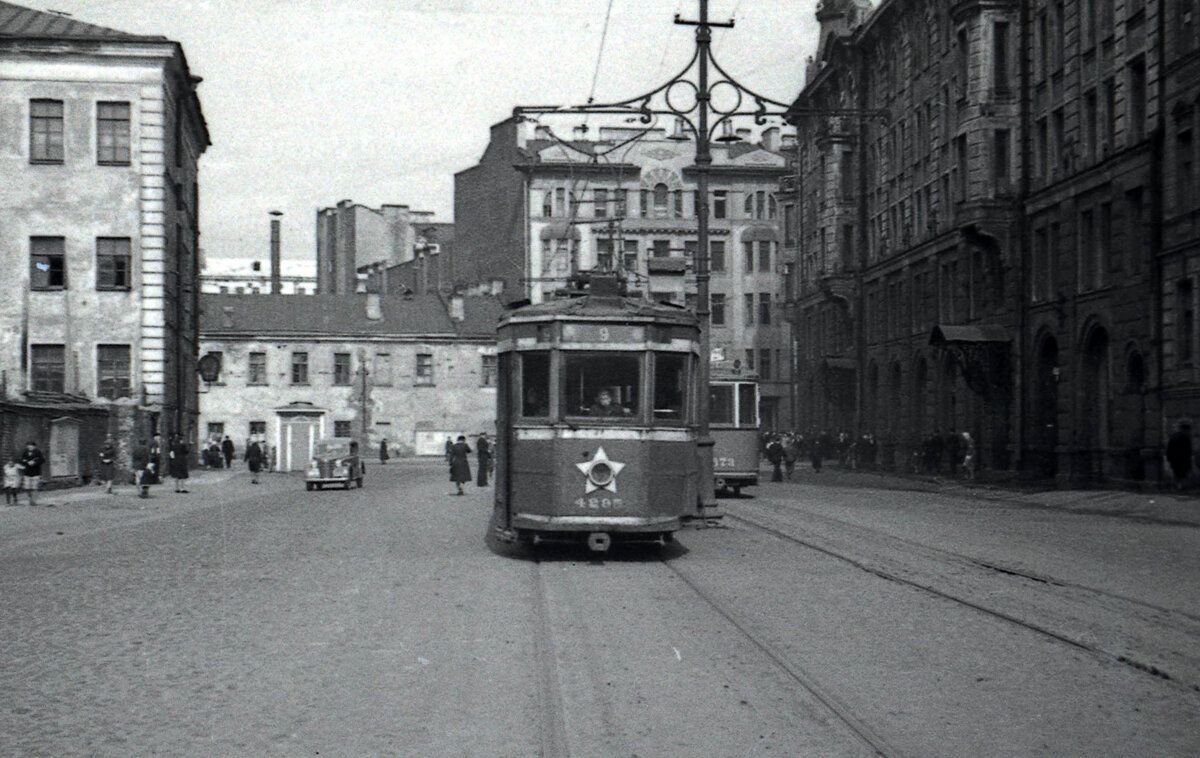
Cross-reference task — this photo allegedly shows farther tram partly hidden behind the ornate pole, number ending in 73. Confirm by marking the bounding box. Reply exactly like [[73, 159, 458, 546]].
[[708, 367, 760, 495]]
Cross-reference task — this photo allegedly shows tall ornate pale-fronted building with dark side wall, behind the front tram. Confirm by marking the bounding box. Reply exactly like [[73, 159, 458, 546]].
[[449, 119, 791, 428]]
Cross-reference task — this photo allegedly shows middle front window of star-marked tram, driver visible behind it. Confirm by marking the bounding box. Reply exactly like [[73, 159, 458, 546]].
[[563, 353, 642, 420]]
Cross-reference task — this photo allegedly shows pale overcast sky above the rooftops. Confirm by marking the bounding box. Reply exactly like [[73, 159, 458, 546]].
[[37, 0, 816, 259]]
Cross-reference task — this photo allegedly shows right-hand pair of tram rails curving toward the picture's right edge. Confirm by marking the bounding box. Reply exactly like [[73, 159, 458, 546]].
[[726, 504, 1200, 693]]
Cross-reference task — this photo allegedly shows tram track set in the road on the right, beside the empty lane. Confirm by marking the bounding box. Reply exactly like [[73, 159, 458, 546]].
[[726, 500, 1200, 692]]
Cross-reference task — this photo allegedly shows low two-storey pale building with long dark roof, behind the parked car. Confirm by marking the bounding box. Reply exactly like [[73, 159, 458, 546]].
[[199, 294, 500, 470]]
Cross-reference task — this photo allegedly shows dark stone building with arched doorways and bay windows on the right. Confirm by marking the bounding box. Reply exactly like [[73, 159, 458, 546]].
[[785, 0, 1195, 480]]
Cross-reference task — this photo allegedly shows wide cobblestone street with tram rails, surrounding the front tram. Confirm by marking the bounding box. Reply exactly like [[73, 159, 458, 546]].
[[0, 461, 1200, 757]]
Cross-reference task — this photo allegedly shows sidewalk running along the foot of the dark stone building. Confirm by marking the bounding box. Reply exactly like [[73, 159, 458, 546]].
[[760, 464, 1200, 528]]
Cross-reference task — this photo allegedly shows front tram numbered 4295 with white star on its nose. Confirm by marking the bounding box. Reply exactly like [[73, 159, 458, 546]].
[[493, 275, 700, 552]]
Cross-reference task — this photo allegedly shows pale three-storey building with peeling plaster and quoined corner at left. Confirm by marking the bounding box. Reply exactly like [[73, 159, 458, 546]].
[[0, 2, 210, 476]]
